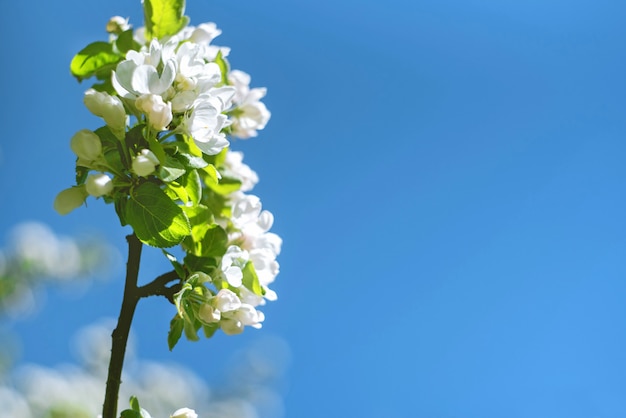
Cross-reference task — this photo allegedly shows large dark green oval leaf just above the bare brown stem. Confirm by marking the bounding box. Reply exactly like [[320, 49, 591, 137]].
[[126, 183, 191, 248]]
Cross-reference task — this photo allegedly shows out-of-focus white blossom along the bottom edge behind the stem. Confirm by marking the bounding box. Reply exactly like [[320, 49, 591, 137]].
[[0, 319, 290, 418]]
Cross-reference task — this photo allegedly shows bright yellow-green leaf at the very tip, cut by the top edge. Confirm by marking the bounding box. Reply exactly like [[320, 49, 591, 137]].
[[143, 0, 189, 40]]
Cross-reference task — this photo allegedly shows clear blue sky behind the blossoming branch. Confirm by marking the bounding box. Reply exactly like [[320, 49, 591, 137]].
[[0, 0, 626, 418]]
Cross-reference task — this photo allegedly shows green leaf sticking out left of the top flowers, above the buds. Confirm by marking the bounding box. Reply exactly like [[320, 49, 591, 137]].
[[70, 42, 124, 81]]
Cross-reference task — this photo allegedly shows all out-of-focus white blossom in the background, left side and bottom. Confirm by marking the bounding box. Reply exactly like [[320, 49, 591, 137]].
[[0, 221, 290, 418]]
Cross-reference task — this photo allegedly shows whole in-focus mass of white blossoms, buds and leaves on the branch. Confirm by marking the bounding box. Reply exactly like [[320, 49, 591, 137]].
[[54, 0, 282, 349]]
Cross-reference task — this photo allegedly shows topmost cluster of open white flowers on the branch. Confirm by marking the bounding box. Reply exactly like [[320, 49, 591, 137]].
[[111, 23, 270, 155]]
